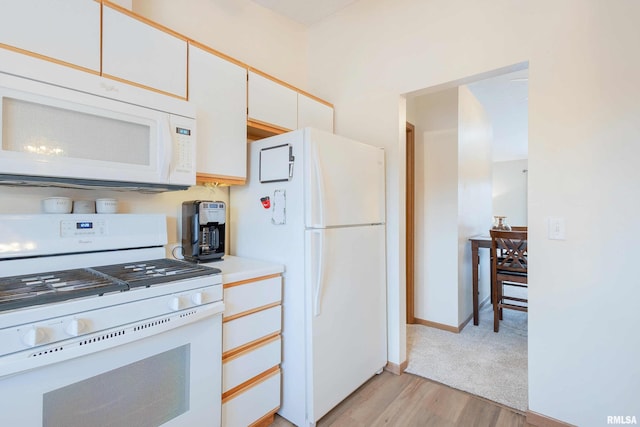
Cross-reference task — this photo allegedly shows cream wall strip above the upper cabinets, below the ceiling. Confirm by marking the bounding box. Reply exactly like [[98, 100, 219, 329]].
[[133, 0, 308, 88]]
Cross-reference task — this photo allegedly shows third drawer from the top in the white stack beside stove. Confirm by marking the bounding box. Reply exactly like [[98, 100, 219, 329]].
[[222, 336, 282, 393]]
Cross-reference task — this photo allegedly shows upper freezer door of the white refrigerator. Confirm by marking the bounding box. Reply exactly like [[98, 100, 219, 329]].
[[304, 129, 385, 228]]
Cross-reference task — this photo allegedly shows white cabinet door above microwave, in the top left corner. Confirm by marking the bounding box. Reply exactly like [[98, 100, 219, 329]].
[[0, 0, 100, 73]]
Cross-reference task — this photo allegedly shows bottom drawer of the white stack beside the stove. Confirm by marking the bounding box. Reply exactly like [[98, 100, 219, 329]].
[[222, 369, 280, 427]]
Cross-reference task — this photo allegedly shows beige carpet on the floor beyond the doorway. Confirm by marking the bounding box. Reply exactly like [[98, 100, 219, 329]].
[[406, 304, 528, 411]]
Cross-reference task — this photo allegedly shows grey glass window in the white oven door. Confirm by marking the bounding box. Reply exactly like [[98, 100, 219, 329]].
[[42, 344, 190, 427]]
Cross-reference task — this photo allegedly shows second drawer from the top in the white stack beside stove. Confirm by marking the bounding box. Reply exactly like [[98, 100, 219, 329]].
[[222, 305, 282, 353]]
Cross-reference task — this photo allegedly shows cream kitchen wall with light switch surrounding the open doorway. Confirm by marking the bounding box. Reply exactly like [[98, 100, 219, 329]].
[[309, 0, 640, 426]]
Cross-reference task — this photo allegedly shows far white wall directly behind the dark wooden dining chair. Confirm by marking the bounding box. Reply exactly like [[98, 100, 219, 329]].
[[493, 159, 529, 225]]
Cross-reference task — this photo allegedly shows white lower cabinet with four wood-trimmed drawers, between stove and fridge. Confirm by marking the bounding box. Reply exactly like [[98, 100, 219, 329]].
[[222, 274, 282, 427]]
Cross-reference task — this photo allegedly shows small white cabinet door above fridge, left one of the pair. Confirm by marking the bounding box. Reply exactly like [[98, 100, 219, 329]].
[[248, 71, 298, 130]]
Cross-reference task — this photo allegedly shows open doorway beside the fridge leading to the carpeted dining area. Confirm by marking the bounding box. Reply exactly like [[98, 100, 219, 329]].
[[405, 64, 528, 410]]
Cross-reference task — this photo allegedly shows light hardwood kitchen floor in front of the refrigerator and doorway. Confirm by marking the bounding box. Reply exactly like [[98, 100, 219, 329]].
[[271, 371, 533, 427]]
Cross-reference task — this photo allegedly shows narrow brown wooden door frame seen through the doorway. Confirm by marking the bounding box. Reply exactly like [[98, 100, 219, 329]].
[[405, 122, 416, 324]]
